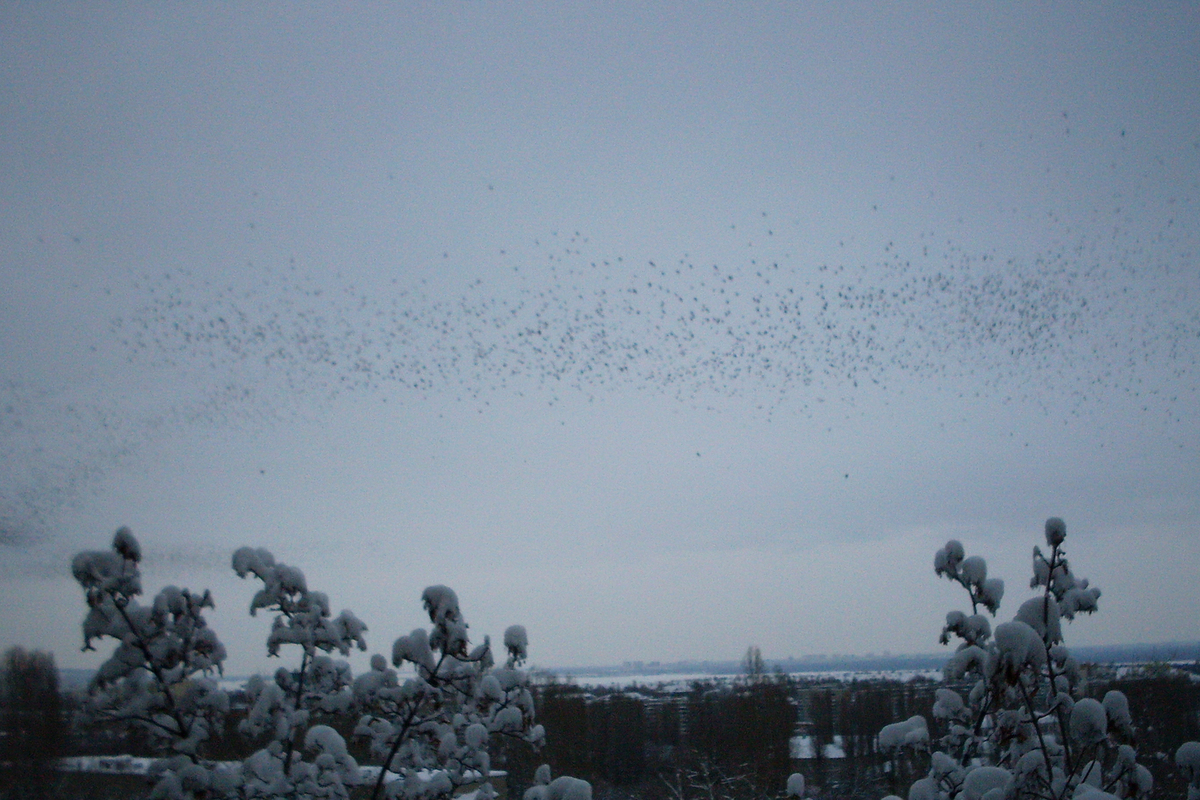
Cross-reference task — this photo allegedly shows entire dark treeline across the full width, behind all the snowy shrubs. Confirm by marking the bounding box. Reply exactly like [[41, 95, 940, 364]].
[[11, 652, 1200, 800]]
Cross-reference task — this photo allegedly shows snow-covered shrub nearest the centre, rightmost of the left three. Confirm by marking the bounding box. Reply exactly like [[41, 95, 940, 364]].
[[354, 587, 549, 798]]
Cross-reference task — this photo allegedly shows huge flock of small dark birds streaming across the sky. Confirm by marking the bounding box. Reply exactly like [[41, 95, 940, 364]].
[[0, 203, 1200, 554]]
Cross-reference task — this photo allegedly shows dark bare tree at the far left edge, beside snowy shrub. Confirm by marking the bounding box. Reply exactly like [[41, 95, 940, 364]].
[[0, 648, 64, 800]]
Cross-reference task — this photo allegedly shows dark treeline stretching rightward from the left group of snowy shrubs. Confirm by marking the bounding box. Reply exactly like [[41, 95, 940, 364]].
[[502, 669, 1200, 800]]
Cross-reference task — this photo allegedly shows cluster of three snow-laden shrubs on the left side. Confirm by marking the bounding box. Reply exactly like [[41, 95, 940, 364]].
[[72, 528, 592, 800]]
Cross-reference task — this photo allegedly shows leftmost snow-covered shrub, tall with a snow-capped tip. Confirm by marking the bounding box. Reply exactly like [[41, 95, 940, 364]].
[[71, 528, 229, 798]]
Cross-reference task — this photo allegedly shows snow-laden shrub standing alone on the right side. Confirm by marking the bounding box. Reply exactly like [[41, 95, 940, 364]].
[[880, 518, 1161, 800]]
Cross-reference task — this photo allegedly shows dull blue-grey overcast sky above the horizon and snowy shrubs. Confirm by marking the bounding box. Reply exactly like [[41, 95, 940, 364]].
[[0, 1, 1200, 672]]
